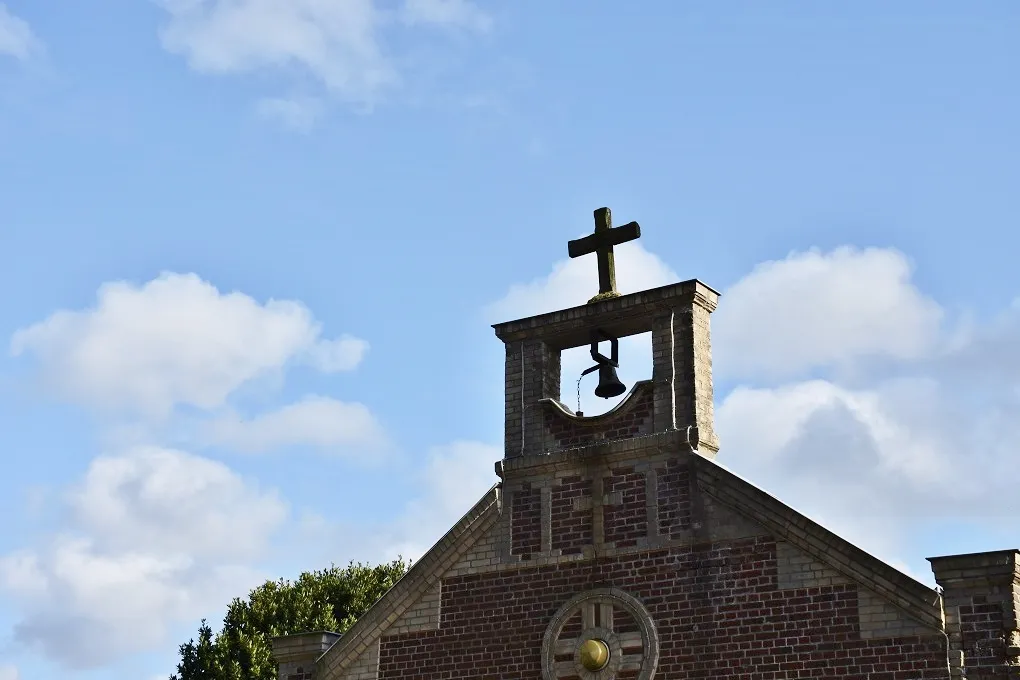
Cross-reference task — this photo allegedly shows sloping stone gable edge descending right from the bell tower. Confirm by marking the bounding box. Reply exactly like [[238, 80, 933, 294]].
[[692, 456, 945, 630]]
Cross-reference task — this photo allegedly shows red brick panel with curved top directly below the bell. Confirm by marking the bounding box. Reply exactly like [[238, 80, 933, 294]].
[[541, 382, 654, 451]]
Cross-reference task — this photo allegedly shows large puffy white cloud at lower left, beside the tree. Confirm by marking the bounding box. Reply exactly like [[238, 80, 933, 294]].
[[0, 449, 287, 669]]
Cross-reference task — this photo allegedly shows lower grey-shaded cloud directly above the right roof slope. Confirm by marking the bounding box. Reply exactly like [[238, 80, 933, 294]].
[[716, 346, 1020, 581]]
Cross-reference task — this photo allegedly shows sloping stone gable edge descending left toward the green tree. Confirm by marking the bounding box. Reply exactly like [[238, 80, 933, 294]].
[[315, 483, 502, 677]]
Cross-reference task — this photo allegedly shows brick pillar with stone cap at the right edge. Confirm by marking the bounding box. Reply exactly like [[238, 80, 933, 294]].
[[928, 550, 1020, 680]]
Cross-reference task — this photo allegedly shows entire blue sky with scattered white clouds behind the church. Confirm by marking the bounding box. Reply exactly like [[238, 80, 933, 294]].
[[0, 0, 1020, 680]]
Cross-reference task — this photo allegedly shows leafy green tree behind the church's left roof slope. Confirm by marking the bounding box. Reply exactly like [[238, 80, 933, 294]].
[[170, 558, 410, 680]]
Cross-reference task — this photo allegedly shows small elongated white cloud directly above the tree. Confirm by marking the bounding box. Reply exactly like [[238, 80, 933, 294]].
[[205, 396, 387, 453]]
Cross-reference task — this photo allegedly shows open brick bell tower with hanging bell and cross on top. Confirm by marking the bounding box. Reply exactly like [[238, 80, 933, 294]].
[[494, 208, 719, 460]]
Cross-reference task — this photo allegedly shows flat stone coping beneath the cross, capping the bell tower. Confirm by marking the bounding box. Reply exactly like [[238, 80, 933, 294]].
[[493, 278, 719, 350]]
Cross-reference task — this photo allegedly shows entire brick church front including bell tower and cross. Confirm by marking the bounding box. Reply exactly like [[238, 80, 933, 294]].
[[273, 210, 1020, 680]]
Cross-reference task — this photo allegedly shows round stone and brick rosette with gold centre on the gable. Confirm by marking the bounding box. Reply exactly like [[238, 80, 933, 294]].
[[542, 588, 659, 680]]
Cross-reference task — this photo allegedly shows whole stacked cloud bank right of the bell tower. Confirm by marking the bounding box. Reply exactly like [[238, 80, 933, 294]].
[[713, 248, 1020, 580]]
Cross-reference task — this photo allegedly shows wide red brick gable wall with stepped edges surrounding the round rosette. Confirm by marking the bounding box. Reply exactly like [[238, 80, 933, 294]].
[[378, 538, 947, 680]]
